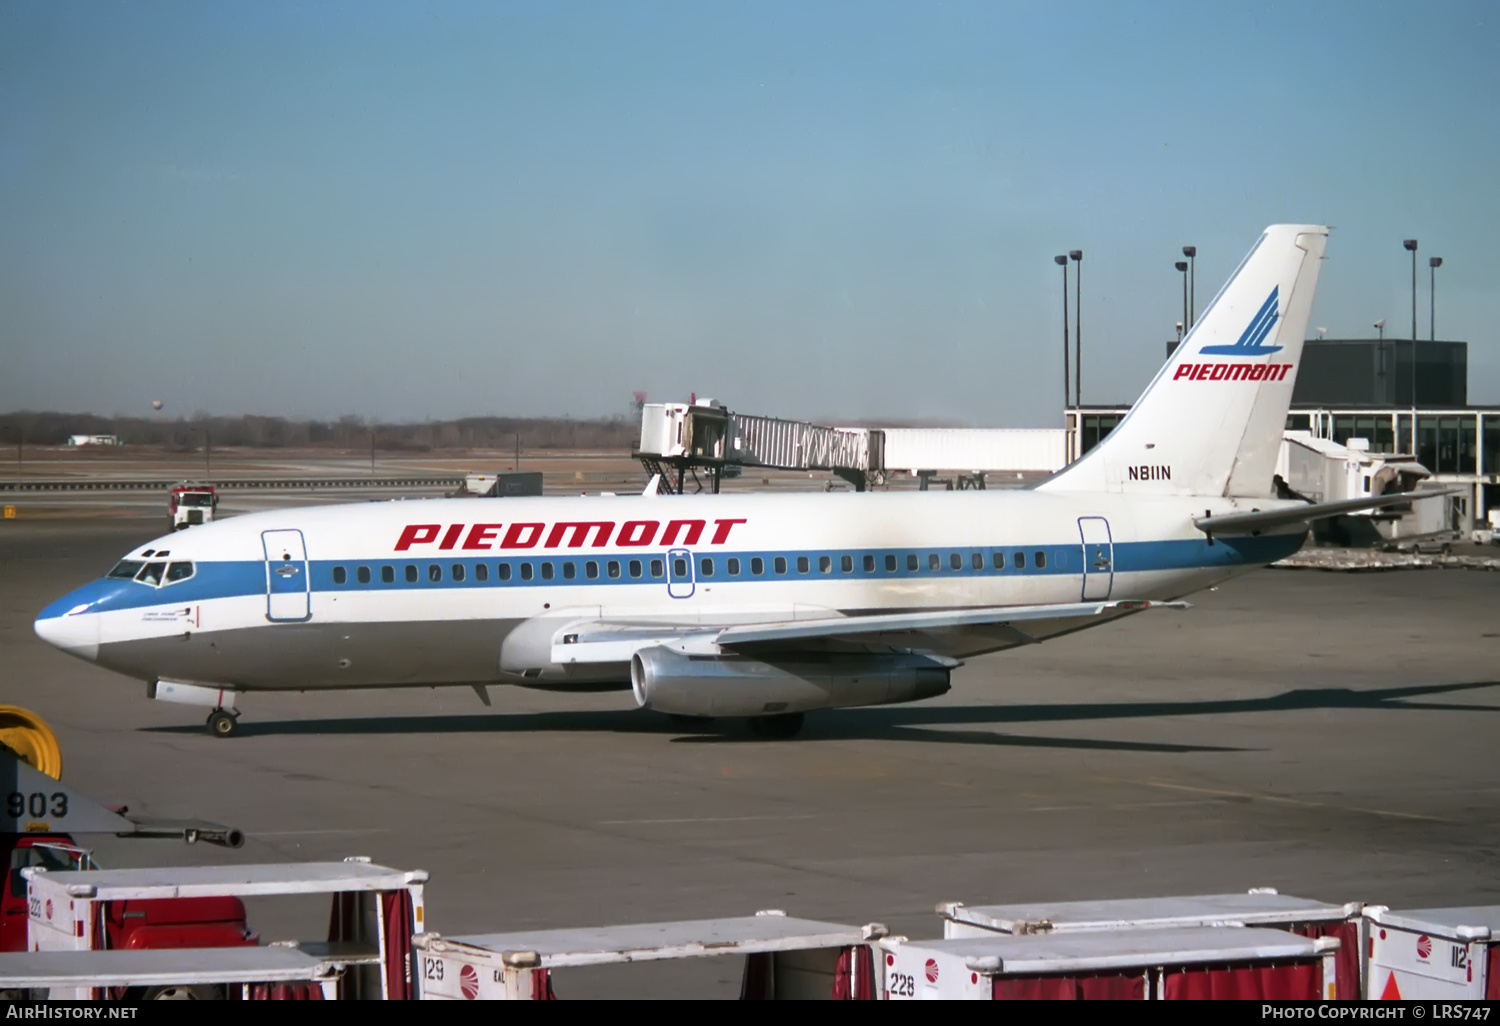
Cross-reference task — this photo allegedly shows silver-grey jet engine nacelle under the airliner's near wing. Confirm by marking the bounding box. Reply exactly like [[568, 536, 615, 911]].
[[630, 647, 957, 716]]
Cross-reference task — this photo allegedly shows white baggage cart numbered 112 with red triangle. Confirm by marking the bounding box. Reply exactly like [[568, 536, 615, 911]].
[[1365, 905, 1500, 1001]]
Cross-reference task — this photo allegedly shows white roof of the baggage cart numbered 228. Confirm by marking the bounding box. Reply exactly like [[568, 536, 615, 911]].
[[903, 927, 1338, 975]]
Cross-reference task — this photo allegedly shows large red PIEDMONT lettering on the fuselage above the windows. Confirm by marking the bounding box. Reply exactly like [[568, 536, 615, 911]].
[[395, 518, 746, 552]]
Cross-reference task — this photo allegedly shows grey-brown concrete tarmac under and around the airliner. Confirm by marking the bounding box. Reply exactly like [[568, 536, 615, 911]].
[[0, 519, 1500, 996]]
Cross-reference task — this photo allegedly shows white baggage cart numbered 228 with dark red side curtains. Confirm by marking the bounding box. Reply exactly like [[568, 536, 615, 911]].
[[879, 926, 1340, 1001]]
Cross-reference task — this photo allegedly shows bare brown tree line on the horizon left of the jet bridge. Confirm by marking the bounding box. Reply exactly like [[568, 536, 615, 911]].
[[0, 411, 639, 452]]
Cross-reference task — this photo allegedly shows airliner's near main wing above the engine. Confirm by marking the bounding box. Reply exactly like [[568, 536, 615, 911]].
[[552, 599, 1188, 665]]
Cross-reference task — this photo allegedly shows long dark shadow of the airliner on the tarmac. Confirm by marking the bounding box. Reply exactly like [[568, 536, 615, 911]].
[[141, 681, 1500, 753]]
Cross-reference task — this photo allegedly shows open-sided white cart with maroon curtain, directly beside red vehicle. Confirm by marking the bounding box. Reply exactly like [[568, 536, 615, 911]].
[[23, 858, 428, 999]]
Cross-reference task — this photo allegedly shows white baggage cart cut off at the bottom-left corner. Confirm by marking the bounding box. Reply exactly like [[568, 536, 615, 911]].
[[0, 945, 339, 1001]]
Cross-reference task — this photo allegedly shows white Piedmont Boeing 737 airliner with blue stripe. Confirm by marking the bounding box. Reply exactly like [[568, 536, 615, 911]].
[[36, 225, 1385, 737]]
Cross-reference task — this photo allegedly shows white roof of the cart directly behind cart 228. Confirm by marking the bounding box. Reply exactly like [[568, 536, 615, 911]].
[[938, 891, 1359, 933]]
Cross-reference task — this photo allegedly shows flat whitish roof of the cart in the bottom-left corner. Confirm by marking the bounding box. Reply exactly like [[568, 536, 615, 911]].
[[0, 948, 335, 987]]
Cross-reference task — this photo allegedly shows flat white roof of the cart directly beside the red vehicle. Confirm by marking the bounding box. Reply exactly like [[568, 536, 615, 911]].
[[23, 863, 428, 900]]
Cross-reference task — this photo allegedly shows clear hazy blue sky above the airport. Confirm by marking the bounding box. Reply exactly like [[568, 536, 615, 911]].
[[0, 0, 1500, 426]]
